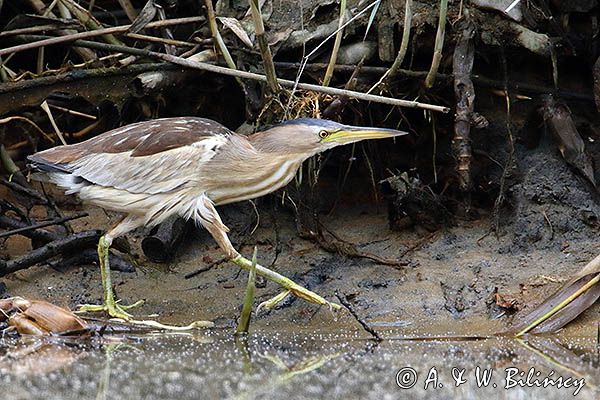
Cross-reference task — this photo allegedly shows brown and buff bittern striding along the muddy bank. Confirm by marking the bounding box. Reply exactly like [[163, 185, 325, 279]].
[[28, 117, 407, 320]]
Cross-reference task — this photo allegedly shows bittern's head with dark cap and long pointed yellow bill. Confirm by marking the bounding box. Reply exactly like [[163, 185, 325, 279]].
[[254, 118, 407, 156]]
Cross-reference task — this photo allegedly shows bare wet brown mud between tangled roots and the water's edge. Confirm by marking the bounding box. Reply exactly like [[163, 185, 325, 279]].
[[2, 173, 598, 336]]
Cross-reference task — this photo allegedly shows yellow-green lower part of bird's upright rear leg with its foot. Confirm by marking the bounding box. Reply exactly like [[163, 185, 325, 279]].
[[77, 236, 144, 320]]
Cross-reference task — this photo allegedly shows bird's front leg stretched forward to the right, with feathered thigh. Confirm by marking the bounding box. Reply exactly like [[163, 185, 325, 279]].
[[199, 197, 341, 309]]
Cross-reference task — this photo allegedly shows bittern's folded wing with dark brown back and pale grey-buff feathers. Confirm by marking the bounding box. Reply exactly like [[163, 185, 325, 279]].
[[29, 118, 234, 194]]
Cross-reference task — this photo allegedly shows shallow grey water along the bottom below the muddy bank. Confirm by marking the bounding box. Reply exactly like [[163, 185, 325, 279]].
[[0, 331, 600, 400]]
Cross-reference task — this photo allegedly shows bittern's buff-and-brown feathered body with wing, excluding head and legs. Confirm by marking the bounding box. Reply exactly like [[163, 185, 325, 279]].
[[29, 118, 312, 230]]
